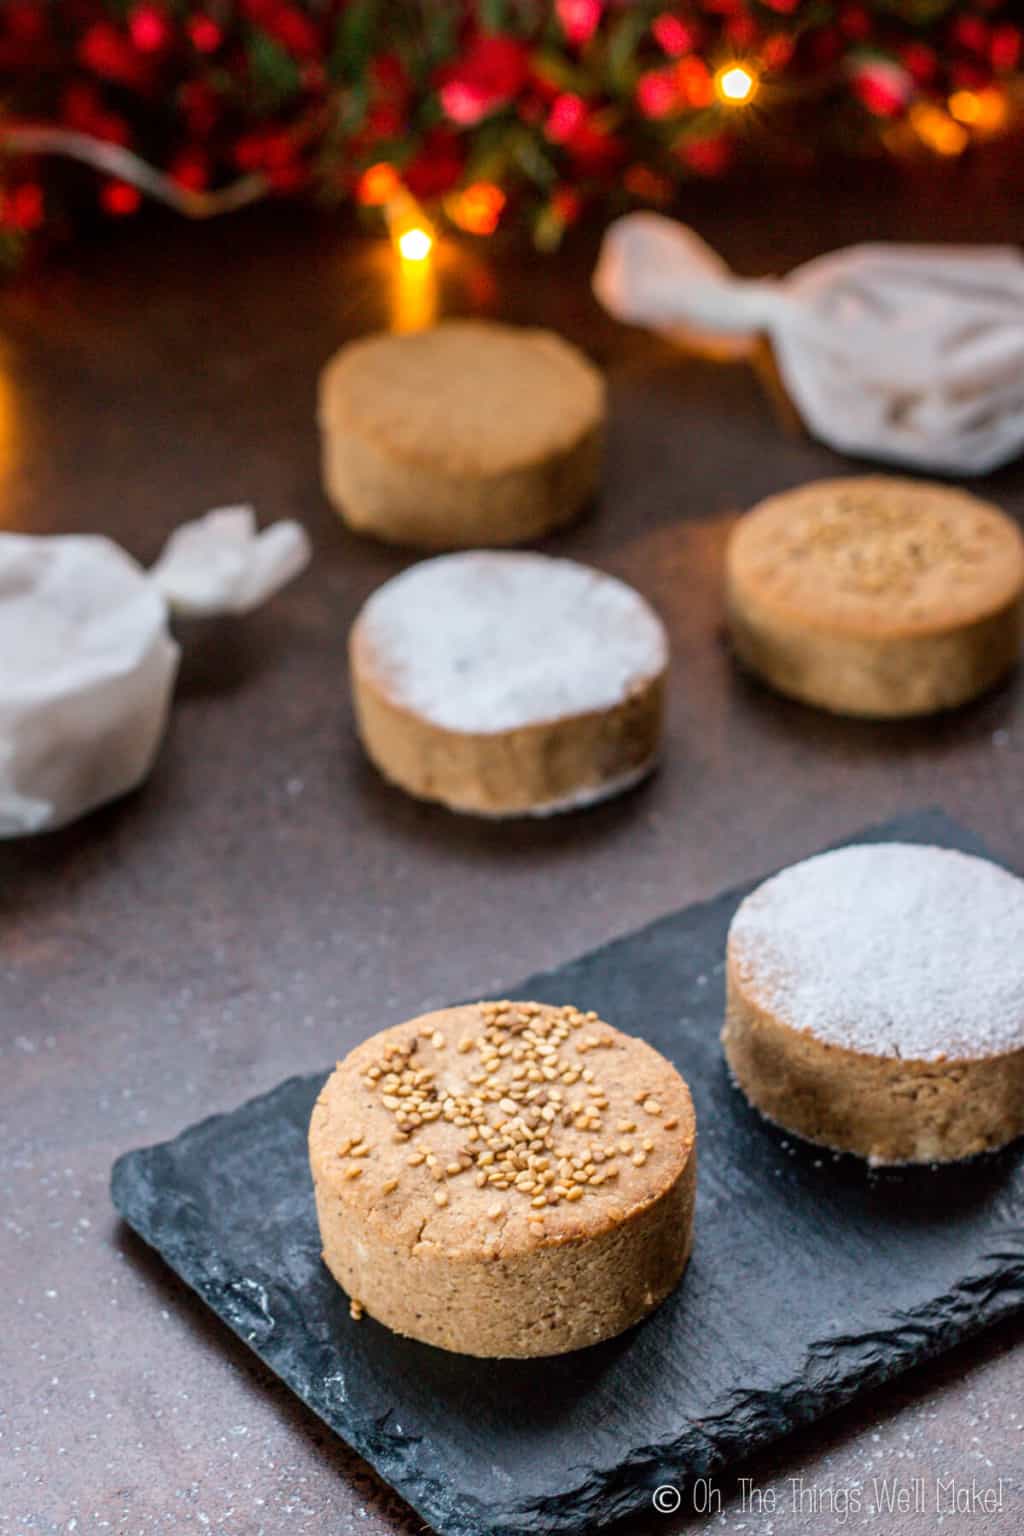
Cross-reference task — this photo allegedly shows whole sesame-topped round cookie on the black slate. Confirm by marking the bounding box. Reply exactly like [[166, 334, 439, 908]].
[[310, 1001, 697, 1356]]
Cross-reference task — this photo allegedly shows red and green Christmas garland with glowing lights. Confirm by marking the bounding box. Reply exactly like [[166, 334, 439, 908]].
[[0, 0, 1022, 257]]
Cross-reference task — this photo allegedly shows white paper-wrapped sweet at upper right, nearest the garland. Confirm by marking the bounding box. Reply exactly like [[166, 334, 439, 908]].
[[594, 214, 1024, 475]]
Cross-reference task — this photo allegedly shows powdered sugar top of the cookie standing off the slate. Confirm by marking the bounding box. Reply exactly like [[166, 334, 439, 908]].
[[356, 551, 668, 733]]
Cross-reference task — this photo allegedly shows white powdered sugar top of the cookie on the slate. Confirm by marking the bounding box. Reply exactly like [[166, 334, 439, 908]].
[[729, 843, 1024, 1061]]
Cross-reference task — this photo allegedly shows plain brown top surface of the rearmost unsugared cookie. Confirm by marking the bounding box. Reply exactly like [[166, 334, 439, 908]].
[[319, 319, 605, 476]]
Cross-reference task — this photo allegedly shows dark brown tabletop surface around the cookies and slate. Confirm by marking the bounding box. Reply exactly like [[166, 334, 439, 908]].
[[0, 168, 1024, 1536]]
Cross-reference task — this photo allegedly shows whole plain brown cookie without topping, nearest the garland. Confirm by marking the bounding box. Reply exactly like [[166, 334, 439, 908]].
[[319, 319, 605, 550]]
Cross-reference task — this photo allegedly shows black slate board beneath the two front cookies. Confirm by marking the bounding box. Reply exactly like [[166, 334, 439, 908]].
[[105, 811, 1024, 1536]]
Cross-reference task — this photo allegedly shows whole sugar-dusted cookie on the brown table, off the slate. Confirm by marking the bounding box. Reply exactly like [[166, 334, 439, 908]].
[[348, 551, 668, 817]]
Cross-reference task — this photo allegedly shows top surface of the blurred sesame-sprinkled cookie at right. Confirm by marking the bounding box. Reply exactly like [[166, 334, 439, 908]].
[[728, 475, 1024, 634]]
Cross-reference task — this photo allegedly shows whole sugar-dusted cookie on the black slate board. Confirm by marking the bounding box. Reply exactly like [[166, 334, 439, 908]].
[[722, 843, 1024, 1164]]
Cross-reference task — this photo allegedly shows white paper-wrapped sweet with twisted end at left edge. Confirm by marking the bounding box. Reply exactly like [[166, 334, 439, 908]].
[[0, 507, 309, 837]]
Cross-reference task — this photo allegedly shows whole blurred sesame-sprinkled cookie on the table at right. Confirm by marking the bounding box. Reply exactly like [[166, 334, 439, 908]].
[[726, 476, 1024, 717]]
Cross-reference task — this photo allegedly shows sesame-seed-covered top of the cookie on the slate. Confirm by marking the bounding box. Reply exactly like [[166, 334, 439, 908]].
[[310, 1001, 695, 1258]]
